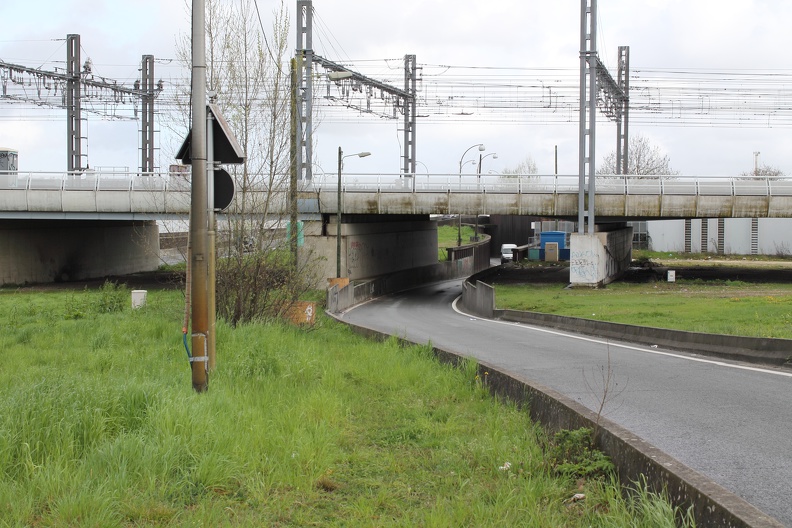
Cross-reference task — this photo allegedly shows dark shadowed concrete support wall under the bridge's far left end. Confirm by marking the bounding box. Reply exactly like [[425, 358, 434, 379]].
[[0, 220, 160, 284]]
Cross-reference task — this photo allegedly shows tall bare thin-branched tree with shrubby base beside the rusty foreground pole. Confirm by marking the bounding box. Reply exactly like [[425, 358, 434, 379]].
[[175, 0, 320, 324]]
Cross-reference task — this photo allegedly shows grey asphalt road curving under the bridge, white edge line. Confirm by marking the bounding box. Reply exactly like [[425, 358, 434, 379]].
[[342, 280, 792, 527]]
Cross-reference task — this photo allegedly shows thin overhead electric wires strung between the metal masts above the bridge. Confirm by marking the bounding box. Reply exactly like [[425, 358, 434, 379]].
[[0, 52, 792, 127]]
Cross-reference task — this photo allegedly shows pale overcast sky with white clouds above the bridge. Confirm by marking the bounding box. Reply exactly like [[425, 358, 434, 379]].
[[0, 0, 792, 175]]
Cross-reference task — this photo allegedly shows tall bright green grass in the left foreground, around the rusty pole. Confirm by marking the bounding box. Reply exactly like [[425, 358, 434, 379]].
[[0, 287, 692, 527]]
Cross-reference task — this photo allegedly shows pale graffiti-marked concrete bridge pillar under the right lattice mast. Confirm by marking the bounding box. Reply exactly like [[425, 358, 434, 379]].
[[569, 226, 632, 288]]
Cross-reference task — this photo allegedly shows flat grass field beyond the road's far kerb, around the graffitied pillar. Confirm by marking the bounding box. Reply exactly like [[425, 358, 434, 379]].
[[495, 253, 792, 339]]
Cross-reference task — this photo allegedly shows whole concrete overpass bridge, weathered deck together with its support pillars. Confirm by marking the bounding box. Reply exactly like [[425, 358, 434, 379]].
[[0, 171, 792, 285]]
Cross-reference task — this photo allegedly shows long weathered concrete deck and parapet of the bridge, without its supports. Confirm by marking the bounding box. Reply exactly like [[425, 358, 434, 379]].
[[0, 171, 792, 221]]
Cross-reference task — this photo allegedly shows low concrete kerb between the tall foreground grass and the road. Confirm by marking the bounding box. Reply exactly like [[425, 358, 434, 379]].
[[328, 314, 783, 528]]
